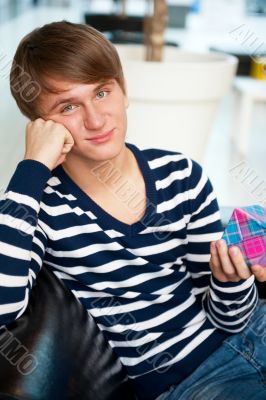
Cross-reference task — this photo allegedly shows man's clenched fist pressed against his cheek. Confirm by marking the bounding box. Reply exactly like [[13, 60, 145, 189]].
[[24, 118, 74, 170]]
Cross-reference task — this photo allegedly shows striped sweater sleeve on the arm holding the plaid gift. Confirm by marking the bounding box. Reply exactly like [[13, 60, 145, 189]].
[[187, 162, 258, 333]]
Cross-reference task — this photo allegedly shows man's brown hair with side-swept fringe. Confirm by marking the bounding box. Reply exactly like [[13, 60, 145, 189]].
[[10, 21, 125, 120]]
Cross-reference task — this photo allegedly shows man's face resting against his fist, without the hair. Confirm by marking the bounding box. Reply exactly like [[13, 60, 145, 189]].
[[40, 79, 127, 161]]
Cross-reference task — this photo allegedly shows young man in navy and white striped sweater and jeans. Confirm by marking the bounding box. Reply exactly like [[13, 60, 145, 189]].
[[0, 22, 266, 400]]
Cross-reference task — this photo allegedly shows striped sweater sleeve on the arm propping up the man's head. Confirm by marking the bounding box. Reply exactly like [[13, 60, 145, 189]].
[[0, 160, 51, 325]]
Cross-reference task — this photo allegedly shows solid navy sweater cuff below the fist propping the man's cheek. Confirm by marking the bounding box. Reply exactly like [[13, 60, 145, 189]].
[[6, 160, 51, 202]]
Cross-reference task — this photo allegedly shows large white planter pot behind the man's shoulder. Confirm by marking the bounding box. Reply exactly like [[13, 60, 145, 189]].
[[116, 45, 237, 162]]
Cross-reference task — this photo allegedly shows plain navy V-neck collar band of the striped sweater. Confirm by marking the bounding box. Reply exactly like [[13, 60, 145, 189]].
[[54, 143, 157, 236]]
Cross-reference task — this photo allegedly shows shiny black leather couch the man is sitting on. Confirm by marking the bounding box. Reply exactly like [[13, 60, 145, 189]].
[[0, 267, 266, 400]]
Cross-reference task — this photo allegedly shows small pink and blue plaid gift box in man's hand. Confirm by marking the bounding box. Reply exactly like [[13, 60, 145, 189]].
[[222, 205, 266, 267]]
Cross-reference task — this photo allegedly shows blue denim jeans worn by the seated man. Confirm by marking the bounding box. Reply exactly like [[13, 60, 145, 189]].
[[156, 300, 266, 400]]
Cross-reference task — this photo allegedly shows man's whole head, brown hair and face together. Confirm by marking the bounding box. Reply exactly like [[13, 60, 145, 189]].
[[10, 21, 130, 163]]
